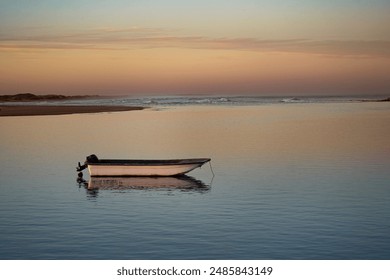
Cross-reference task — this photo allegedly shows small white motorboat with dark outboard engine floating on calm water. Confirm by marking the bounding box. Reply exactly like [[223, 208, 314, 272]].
[[77, 155, 211, 177]]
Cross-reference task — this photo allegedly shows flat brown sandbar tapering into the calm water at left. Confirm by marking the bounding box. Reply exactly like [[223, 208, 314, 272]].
[[0, 105, 144, 117]]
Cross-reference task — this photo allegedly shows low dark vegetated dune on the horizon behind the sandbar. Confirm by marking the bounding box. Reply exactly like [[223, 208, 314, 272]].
[[0, 93, 99, 102]]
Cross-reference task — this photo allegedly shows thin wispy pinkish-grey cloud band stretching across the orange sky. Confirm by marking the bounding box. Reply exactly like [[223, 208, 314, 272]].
[[0, 27, 390, 58]]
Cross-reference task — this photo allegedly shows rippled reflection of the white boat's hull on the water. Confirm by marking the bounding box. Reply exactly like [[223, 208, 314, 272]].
[[83, 175, 210, 194]]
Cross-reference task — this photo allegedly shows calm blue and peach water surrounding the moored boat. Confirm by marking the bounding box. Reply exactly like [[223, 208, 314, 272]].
[[0, 103, 390, 259]]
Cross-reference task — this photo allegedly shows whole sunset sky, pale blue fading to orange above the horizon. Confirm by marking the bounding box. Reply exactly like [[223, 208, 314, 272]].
[[0, 0, 390, 96]]
